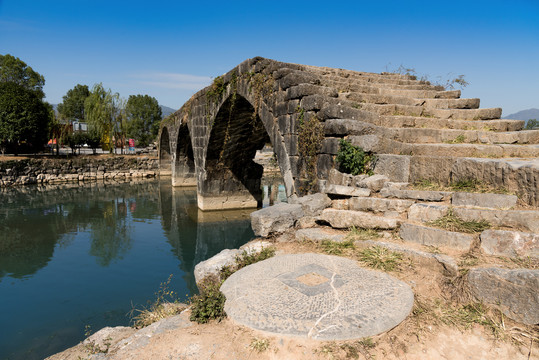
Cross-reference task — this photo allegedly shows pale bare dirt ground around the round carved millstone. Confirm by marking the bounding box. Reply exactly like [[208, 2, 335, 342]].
[[50, 234, 539, 360]]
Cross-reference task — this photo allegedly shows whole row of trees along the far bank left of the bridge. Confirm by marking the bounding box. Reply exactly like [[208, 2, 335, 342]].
[[0, 54, 162, 154]]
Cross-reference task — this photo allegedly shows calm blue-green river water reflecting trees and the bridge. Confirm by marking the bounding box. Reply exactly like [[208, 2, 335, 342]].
[[0, 180, 267, 359]]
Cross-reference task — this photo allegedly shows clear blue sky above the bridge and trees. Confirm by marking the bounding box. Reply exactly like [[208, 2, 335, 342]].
[[0, 0, 539, 115]]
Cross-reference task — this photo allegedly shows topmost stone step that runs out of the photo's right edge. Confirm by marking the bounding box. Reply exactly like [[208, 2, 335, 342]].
[[324, 119, 539, 144]]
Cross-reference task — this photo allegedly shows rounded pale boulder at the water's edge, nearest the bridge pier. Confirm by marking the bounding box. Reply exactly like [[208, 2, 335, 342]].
[[251, 203, 305, 236]]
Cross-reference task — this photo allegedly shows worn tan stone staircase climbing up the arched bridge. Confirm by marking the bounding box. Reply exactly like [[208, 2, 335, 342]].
[[273, 63, 539, 206]]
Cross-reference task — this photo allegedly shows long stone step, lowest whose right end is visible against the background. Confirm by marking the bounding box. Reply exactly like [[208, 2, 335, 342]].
[[374, 115, 525, 132]]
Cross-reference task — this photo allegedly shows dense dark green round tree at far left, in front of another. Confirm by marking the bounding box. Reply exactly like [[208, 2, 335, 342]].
[[0, 82, 50, 154]]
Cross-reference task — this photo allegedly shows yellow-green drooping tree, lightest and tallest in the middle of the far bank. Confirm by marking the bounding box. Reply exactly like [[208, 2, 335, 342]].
[[84, 83, 123, 151]]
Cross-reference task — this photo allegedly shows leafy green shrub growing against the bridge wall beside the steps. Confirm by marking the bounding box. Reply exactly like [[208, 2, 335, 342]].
[[337, 139, 376, 175]]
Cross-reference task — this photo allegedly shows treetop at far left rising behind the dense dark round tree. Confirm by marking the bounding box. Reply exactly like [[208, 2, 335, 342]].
[[0, 54, 45, 100]]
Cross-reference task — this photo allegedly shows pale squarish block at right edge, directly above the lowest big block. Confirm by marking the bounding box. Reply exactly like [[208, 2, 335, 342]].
[[481, 230, 539, 258]]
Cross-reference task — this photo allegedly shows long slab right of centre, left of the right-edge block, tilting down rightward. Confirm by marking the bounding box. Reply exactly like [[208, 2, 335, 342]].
[[399, 223, 474, 250]]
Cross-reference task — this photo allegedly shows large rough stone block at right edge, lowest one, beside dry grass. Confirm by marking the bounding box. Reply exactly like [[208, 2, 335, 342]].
[[468, 267, 539, 325]]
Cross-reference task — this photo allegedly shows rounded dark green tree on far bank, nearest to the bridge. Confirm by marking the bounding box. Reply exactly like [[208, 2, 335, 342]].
[[125, 95, 162, 146]]
